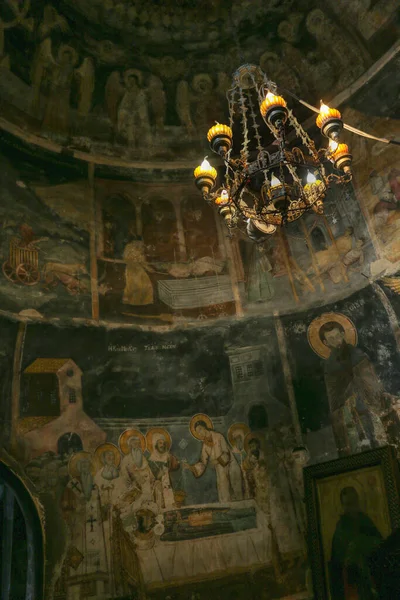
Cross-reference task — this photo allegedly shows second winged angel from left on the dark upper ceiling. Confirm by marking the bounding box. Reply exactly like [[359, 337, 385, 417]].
[[106, 69, 151, 148]]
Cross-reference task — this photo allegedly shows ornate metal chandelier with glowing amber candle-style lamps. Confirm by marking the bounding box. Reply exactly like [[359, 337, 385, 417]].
[[194, 65, 352, 242]]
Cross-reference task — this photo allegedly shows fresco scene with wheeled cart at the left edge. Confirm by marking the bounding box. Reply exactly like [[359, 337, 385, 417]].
[[0, 145, 90, 318]]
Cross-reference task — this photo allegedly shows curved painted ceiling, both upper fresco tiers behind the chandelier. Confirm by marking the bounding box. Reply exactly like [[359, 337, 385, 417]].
[[0, 0, 400, 327]]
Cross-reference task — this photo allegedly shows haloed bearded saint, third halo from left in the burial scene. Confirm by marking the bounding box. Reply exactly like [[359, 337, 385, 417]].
[[119, 429, 154, 506]]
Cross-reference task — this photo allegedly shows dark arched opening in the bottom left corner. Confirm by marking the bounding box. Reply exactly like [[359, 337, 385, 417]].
[[0, 461, 44, 600]]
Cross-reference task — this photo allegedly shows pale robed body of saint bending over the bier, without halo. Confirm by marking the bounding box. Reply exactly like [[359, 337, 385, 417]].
[[191, 431, 243, 502]]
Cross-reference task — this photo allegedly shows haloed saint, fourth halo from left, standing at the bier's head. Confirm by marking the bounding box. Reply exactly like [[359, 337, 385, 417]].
[[146, 428, 180, 509]]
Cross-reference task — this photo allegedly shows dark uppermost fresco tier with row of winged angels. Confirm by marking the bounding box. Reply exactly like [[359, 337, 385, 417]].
[[0, 0, 397, 160]]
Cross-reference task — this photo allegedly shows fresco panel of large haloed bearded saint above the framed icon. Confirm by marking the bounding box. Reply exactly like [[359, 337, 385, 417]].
[[284, 284, 400, 460]]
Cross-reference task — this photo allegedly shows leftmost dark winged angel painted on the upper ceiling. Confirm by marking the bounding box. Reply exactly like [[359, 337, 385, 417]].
[[32, 38, 94, 134]]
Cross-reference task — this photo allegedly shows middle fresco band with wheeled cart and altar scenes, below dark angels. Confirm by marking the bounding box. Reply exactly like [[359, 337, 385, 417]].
[[0, 132, 381, 327]]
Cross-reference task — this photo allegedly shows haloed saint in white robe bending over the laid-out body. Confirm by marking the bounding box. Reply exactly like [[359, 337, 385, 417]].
[[183, 414, 243, 502]]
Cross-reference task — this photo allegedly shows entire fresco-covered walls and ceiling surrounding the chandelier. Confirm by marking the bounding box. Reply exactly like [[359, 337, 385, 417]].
[[0, 0, 400, 600]]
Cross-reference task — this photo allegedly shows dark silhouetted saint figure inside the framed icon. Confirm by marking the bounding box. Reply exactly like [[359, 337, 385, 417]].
[[329, 486, 382, 600]]
